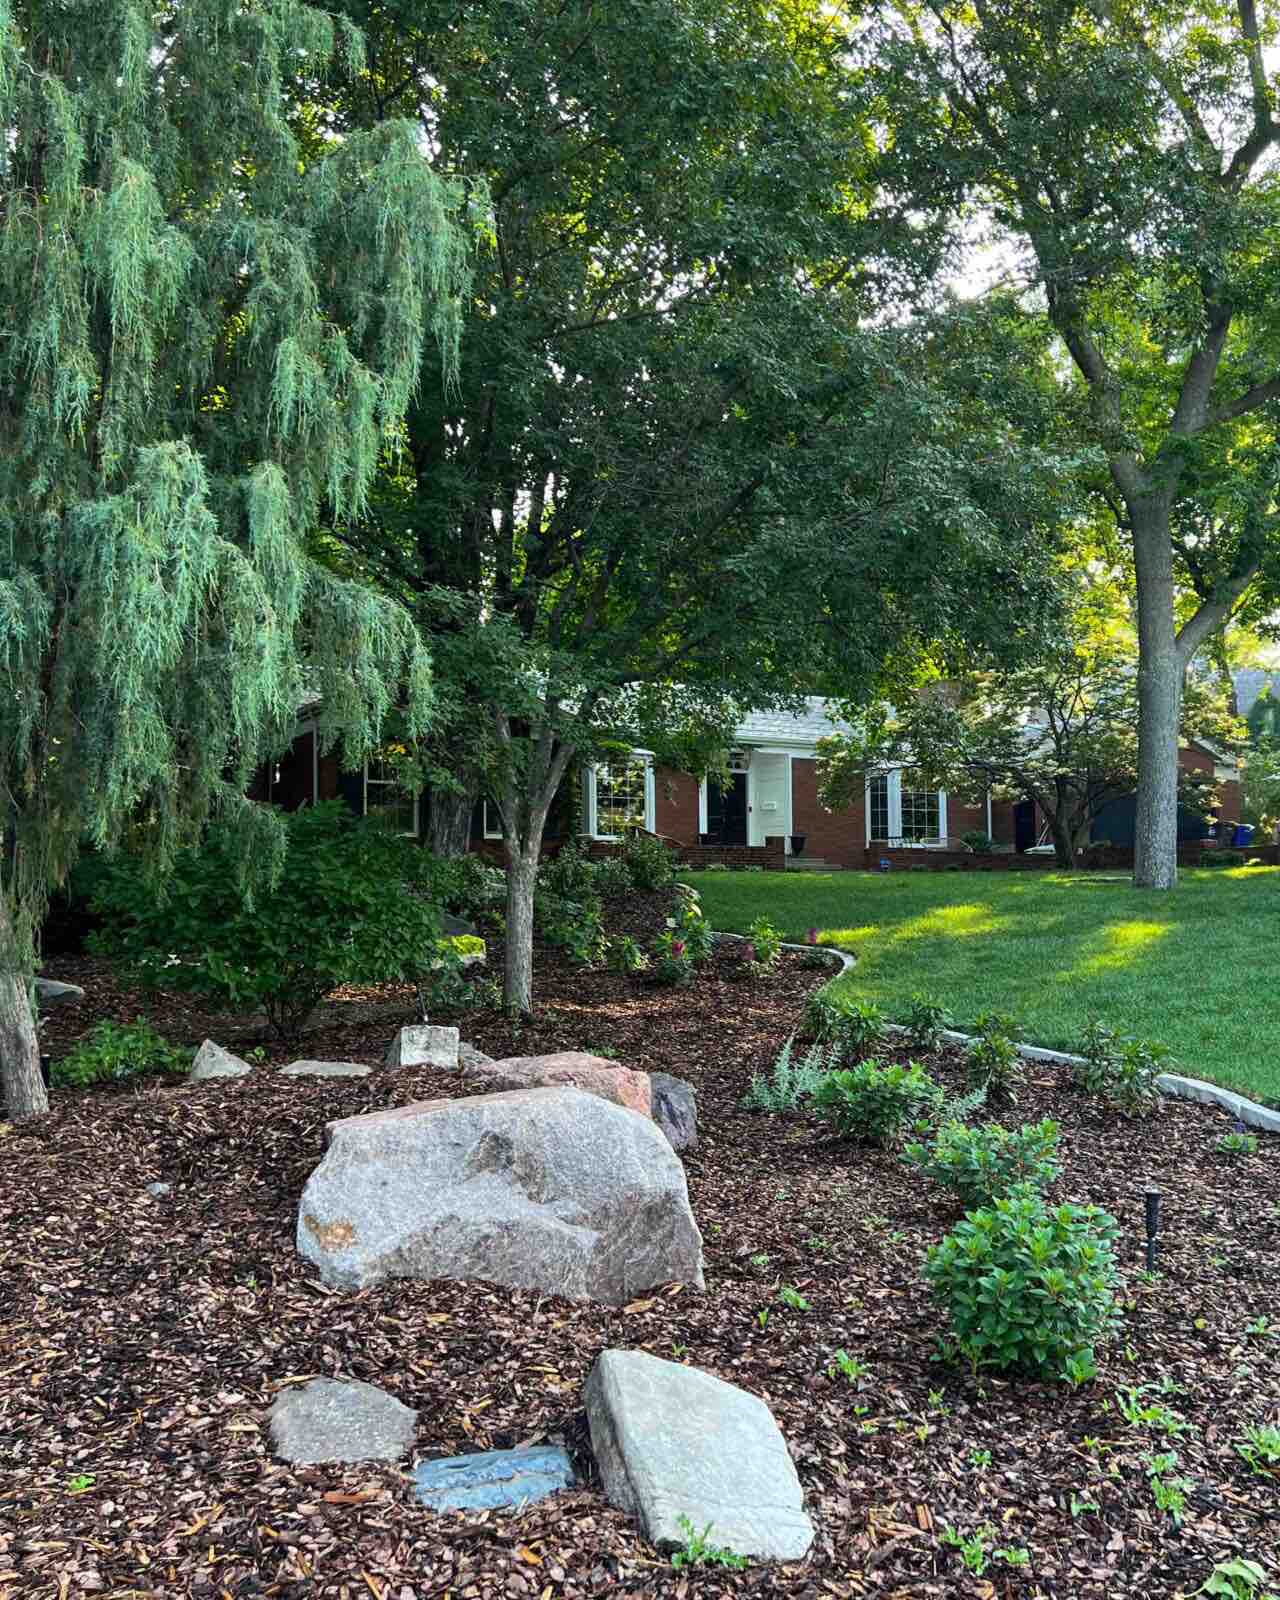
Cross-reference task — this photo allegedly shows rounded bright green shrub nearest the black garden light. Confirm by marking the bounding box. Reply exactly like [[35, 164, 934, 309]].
[[923, 1186, 1118, 1382]]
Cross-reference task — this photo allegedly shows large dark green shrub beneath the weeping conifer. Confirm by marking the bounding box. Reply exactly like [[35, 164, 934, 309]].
[[91, 802, 445, 1037]]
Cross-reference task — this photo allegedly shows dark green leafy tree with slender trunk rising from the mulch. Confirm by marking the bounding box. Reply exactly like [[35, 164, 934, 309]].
[[315, 0, 1075, 1010]]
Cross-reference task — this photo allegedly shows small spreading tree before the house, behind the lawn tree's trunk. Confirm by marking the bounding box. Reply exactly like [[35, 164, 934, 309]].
[[819, 638, 1243, 870]]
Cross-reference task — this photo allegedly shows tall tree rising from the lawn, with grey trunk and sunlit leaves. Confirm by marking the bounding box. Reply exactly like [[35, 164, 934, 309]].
[[850, 0, 1280, 888]]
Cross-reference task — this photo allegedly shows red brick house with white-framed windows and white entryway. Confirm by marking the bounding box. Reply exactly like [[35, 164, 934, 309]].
[[253, 698, 1240, 867]]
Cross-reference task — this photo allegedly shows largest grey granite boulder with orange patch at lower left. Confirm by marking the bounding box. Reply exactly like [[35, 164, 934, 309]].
[[298, 1088, 702, 1306]]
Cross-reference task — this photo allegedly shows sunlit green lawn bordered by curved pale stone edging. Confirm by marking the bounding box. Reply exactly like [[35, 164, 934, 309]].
[[688, 867, 1280, 1102]]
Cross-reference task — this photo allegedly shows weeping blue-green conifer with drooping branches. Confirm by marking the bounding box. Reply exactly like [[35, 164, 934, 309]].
[[0, 0, 469, 1117]]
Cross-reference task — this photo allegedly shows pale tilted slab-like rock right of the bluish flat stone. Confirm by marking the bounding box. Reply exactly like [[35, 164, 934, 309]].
[[584, 1350, 813, 1562]]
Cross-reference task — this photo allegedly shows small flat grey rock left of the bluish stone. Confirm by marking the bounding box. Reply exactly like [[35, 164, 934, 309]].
[[267, 1378, 418, 1467]]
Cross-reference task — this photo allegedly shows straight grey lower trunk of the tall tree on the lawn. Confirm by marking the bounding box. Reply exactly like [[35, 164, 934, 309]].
[[1130, 494, 1182, 890]]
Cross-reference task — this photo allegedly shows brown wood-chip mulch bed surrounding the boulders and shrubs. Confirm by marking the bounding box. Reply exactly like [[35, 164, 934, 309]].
[[0, 899, 1280, 1600]]
